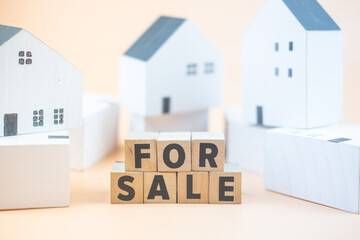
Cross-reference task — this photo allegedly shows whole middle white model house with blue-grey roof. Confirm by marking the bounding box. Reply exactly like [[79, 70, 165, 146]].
[[120, 16, 224, 122]]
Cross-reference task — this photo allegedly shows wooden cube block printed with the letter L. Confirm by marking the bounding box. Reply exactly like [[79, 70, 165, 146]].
[[178, 172, 209, 203]]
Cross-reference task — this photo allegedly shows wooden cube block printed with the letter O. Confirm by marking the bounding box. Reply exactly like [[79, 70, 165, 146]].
[[157, 132, 191, 172]]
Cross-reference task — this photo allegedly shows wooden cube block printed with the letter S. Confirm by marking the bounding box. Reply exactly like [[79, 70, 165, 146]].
[[111, 162, 144, 204]]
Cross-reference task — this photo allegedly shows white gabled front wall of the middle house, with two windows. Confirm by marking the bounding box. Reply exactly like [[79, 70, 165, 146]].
[[145, 21, 224, 116]]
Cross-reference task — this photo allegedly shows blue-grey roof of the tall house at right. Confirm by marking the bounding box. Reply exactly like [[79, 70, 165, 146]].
[[283, 0, 340, 31]]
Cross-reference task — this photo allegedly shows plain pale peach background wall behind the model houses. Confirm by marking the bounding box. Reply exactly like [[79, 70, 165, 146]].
[[0, 0, 360, 123]]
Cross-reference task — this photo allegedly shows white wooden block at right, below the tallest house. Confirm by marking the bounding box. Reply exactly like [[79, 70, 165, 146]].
[[264, 124, 360, 213]]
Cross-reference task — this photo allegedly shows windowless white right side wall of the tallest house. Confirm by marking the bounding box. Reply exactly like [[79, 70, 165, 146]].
[[307, 31, 343, 128]]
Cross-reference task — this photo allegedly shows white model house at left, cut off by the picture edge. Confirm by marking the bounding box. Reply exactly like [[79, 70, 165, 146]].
[[0, 25, 82, 136]]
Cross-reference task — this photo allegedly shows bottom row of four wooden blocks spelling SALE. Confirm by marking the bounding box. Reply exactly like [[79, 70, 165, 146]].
[[111, 162, 241, 204]]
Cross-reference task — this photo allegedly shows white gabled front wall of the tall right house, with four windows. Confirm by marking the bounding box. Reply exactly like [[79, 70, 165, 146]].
[[242, 0, 307, 128]]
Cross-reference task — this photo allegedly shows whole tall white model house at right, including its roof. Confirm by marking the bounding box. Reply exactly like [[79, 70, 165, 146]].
[[243, 0, 343, 128]]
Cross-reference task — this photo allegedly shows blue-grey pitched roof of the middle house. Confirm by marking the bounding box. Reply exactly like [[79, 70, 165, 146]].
[[125, 16, 185, 61]]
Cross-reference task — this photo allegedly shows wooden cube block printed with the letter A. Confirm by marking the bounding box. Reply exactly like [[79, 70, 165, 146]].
[[144, 172, 177, 203]]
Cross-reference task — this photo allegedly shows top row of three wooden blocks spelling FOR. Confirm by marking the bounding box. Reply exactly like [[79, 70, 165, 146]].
[[125, 132, 225, 172]]
